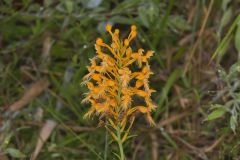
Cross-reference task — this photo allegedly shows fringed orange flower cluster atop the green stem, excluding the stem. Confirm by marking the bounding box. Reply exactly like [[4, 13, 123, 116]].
[[83, 24, 156, 126]]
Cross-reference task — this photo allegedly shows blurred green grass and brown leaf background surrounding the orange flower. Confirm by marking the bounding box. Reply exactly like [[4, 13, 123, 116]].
[[0, 0, 240, 160]]
